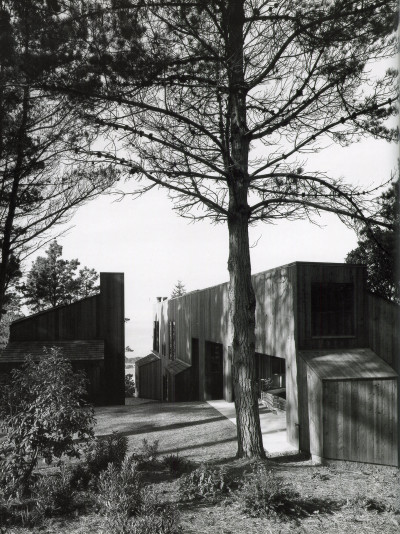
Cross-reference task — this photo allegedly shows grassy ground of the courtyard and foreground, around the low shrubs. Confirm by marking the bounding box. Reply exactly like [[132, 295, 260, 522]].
[[0, 399, 400, 534]]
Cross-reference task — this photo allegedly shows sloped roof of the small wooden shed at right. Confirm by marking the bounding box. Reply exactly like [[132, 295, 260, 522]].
[[299, 349, 397, 380]]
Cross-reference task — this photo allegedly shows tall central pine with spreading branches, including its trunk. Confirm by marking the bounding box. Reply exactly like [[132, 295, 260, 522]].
[[54, 0, 397, 457]]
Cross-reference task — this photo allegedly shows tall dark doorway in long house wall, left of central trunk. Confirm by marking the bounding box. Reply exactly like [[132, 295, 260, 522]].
[[204, 341, 224, 400]]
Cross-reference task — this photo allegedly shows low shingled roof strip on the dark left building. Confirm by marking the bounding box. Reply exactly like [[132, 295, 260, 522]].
[[0, 339, 104, 363]]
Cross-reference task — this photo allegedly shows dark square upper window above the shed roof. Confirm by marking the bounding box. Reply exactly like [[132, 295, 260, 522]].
[[311, 283, 354, 337]]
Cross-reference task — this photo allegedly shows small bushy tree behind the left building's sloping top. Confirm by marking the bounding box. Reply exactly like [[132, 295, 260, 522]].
[[21, 241, 99, 312]]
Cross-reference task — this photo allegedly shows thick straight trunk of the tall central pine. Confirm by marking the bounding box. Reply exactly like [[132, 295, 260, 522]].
[[226, 0, 265, 458]]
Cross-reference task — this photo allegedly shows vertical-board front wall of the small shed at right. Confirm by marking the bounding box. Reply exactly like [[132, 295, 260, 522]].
[[322, 379, 398, 466]]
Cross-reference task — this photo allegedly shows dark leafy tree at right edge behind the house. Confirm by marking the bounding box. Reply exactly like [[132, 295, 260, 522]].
[[346, 180, 400, 304]]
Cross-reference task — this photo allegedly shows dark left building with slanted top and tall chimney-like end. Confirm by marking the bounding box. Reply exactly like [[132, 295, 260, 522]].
[[0, 273, 125, 405]]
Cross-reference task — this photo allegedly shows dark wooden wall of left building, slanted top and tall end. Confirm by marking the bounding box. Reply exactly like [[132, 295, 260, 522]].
[[6, 273, 125, 405]]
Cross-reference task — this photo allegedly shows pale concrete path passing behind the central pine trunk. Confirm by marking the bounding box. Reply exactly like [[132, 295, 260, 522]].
[[207, 400, 298, 455]]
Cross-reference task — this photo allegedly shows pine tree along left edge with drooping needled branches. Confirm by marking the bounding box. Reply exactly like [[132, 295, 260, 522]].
[[0, 0, 119, 321]]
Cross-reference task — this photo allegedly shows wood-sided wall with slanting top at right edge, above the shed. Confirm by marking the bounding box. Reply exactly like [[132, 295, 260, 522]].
[[367, 293, 400, 373]]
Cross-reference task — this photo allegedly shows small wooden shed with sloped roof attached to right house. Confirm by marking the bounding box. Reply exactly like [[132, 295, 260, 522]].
[[298, 348, 398, 466]]
